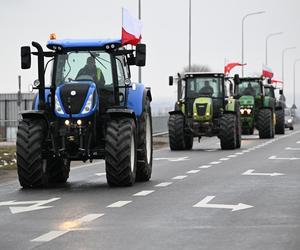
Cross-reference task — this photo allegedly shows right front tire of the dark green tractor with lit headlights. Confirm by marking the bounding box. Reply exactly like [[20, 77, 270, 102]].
[[257, 109, 274, 139]]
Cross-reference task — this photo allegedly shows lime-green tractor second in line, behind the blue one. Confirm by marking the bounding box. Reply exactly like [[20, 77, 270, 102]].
[[168, 72, 241, 150]]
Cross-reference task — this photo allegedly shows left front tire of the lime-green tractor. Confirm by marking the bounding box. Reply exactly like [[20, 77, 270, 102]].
[[168, 114, 185, 150]]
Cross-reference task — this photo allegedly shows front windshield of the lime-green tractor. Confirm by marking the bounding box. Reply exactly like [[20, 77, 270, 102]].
[[186, 77, 223, 98]]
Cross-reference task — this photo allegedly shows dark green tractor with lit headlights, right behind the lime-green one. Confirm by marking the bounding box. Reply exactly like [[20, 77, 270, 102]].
[[234, 77, 276, 139]]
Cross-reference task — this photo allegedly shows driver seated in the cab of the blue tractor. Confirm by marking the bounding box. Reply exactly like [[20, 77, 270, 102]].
[[76, 56, 105, 86]]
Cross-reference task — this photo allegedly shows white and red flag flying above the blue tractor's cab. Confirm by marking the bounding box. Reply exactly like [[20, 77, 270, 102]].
[[122, 8, 143, 45]]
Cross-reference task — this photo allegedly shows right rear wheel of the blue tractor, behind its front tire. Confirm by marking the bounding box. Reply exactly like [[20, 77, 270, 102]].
[[136, 98, 153, 181]]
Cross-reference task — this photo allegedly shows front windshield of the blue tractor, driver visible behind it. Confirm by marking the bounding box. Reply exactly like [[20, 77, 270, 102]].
[[55, 51, 113, 87]]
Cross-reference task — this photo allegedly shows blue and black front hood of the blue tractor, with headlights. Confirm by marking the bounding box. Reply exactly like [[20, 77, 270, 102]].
[[55, 81, 99, 118]]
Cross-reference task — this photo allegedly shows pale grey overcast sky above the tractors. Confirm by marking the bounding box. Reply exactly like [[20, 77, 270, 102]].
[[0, 0, 300, 107]]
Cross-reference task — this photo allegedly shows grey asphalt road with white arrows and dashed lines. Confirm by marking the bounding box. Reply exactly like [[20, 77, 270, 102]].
[[0, 126, 300, 250]]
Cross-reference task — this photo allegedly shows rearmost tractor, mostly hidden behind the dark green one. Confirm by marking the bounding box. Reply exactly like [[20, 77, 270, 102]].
[[264, 82, 286, 135]]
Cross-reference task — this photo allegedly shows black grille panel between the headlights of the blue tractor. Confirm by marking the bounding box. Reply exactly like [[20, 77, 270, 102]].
[[60, 83, 90, 114]]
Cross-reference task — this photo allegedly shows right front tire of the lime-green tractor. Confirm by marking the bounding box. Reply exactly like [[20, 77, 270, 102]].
[[219, 113, 237, 149]]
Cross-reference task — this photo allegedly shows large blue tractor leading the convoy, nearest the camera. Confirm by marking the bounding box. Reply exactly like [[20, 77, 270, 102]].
[[17, 38, 153, 188]]
